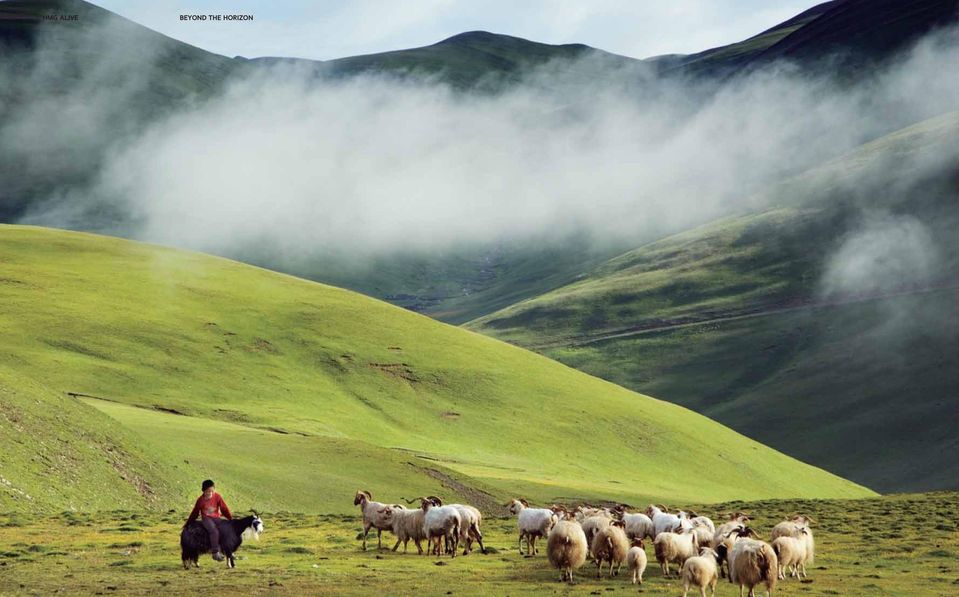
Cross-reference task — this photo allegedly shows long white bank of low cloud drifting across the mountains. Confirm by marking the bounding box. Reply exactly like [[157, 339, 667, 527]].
[[0, 19, 959, 270]]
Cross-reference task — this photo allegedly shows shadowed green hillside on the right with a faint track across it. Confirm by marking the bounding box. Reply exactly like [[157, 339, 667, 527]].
[[468, 114, 959, 490]]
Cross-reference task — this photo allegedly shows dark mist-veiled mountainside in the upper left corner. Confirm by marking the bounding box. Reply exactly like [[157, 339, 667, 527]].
[[0, 0, 242, 222]]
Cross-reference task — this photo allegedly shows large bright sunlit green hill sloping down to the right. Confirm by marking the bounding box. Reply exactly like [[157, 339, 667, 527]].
[[0, 226, 868, 511]]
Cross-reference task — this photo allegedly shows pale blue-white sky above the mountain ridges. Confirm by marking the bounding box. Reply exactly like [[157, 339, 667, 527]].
[[94, 0, 817, 60]]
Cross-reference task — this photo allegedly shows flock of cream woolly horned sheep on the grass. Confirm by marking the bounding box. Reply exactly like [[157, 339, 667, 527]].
[[353, 491, 815, 597]]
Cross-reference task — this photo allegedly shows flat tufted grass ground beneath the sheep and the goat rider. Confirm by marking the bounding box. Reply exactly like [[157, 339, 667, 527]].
[[0, 493, 959, 597]]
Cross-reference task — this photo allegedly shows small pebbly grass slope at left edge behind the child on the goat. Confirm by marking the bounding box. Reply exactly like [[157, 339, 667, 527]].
[[0, 366, 197, 511]]
